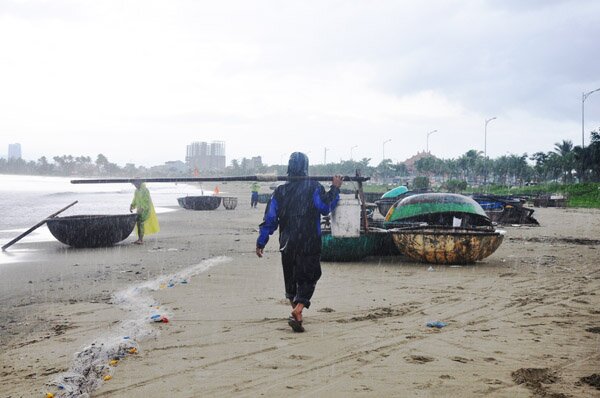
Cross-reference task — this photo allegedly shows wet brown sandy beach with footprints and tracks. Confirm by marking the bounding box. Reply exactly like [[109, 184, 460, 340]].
[[0, 184, 600, 398]]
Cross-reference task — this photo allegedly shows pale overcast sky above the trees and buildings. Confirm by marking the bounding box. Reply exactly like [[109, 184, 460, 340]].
[[0, 0, 600, 166]]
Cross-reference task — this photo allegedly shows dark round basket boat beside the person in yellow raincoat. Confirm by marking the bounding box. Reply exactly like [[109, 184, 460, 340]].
[[46, 213, 137, 247]]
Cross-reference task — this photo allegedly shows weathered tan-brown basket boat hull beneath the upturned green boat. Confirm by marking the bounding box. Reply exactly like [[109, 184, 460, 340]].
[[391, 228, 504, 264]]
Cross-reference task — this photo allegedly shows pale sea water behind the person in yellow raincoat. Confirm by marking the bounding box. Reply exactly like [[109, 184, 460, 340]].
[[0, 174, 211, 246]]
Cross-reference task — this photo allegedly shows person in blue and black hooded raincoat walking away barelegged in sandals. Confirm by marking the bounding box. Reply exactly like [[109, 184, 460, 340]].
[[256, 152, 342, 332]]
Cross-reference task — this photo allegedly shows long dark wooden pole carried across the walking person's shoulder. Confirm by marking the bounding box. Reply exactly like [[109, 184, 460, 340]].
[[71, 175, 371, 184]]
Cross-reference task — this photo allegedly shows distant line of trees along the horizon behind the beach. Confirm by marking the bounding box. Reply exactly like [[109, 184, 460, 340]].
[[0, 130, 600, 185]]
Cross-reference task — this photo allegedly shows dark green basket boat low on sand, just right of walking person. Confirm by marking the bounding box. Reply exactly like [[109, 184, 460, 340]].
[[321, 231, 379, 261]]
